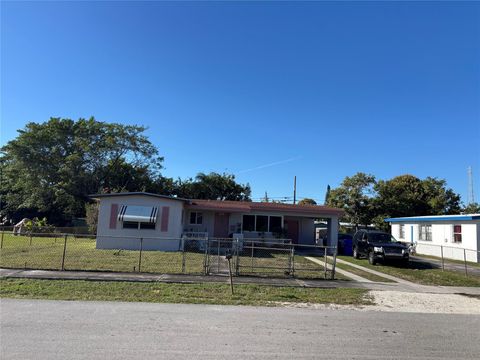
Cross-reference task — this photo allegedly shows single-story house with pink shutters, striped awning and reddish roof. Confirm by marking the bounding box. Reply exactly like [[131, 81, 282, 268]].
[[90, 192, 343, 251]]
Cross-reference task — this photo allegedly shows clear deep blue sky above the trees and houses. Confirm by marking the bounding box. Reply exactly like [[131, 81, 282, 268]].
[[1, 1, 480, 202]]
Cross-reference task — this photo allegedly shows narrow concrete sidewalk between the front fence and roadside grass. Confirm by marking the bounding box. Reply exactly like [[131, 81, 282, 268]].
[[0, 268, 480, 295]]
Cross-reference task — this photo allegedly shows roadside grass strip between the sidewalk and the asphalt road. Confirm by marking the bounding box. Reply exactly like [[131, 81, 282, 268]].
[[0, 279, 372, 306]]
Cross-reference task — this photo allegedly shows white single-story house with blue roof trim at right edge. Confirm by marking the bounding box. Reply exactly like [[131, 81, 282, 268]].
[[385, 214, 480, 262]]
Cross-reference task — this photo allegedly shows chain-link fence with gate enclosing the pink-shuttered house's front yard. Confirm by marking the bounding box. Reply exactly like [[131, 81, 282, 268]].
[[0, 231, 336, 279]]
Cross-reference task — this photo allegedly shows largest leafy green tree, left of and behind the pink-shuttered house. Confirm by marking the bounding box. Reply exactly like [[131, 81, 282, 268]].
[[0, 117, 163, 224]]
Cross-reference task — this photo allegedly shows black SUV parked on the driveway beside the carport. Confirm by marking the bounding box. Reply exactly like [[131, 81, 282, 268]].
[[352, 230, 409, 265]]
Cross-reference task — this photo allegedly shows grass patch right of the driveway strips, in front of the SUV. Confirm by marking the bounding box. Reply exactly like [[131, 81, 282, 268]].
[[338, 256, 480, 286]]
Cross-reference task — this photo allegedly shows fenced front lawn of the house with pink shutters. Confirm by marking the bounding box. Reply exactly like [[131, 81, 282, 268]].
[[0, 233, 345, 279]]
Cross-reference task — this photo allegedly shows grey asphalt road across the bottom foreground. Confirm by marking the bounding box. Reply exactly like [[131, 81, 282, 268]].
[[0, 299, 480, 360]]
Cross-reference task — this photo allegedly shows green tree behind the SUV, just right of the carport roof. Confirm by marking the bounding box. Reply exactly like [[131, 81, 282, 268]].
[[326, 172, 376, 229]]
